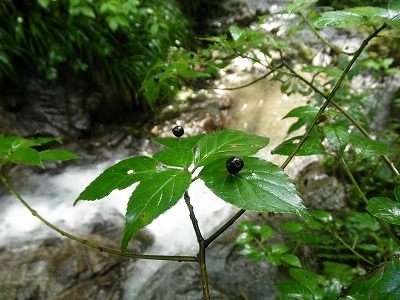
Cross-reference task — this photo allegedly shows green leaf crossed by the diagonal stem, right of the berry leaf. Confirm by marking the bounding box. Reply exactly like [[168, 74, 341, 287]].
[[271, 136, 326, 156]]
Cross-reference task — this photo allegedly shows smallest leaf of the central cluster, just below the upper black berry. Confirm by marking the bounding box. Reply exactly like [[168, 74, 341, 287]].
[[153, 148, 193, 168]]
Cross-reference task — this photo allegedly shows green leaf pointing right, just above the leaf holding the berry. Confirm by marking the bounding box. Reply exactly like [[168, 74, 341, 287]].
[[194, 130, 269, 167]]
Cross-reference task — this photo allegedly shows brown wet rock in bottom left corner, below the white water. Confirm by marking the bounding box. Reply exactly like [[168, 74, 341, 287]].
[[0, 211, 152, 300]]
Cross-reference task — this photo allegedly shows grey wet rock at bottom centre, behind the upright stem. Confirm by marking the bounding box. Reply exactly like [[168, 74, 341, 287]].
[[137, 216, 286, 300]]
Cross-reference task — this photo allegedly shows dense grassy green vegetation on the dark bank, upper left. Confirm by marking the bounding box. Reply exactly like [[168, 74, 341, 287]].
[[0, 0, 191, 106]]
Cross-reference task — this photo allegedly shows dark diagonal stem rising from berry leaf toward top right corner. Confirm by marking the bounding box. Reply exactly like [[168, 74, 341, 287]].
[[281, 24, 386, 169]]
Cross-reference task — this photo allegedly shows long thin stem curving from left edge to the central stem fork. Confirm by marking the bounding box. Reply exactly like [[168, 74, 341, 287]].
[[0, 175, 197, 262]]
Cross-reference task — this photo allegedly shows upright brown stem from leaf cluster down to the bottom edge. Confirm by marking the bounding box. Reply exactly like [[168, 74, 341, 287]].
[[183, 191, 211, 300]]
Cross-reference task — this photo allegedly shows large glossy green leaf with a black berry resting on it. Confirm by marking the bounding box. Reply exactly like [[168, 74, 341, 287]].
[[199, 157, 310, 219]]
